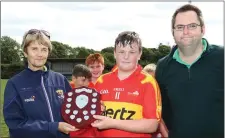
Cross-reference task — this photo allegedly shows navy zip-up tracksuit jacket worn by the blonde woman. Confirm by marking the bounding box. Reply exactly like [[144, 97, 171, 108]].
[[3, 63, 71, 138]]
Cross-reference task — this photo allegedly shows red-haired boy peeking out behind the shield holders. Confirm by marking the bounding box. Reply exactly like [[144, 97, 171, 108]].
[[70, 53, 104, 88]]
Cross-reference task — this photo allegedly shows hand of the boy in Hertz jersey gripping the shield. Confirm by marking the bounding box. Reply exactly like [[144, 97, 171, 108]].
[[91, 115, 116, 129]]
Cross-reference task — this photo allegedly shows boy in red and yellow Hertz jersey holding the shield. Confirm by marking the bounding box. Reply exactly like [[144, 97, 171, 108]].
[[92, 31, 161, 137]]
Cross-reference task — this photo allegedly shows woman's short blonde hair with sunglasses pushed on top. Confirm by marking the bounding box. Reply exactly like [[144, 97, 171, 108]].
[[21, 29, 52, 53]]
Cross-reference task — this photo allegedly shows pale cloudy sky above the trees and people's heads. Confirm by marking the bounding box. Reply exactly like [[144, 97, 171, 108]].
[[1, 2, 224, 50]]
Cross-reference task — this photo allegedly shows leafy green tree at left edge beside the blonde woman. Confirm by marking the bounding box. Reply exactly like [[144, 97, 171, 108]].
[[0, 36, 23, 64]]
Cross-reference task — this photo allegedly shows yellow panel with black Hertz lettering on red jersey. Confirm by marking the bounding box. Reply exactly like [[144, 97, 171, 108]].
[[103, 101, 143, 120]]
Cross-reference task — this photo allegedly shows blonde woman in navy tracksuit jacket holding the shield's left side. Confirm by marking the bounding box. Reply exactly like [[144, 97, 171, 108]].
[[3, 29, 77, 138]]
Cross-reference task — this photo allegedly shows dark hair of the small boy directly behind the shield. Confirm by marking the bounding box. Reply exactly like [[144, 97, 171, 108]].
[[72, 64, 92, 79]]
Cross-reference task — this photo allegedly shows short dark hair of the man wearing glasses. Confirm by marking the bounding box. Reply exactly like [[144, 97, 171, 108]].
[[172, 4, 204, 29]]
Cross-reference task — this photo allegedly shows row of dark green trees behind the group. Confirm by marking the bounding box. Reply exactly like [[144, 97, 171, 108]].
[[0, 36, 171, 76]]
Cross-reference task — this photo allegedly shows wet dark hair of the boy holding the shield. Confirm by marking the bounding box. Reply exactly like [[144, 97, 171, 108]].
[[114, 31, 142, 51]]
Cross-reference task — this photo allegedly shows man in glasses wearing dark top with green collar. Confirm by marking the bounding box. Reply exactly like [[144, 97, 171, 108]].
[[156, 4, 224, 138]]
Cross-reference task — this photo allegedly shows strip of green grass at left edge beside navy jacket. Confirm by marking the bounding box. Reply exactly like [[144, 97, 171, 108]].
[[0, 79, 9, 138]]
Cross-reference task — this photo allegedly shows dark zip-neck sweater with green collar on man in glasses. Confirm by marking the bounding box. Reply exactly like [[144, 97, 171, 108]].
[[156, 39, 224, 138]]
